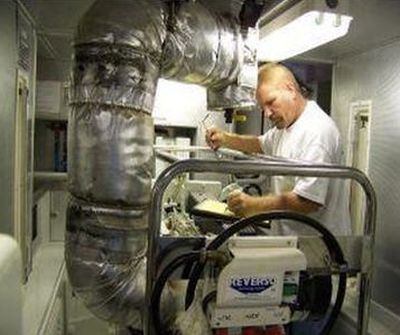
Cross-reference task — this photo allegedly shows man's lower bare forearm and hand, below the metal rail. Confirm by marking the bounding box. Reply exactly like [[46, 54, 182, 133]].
[[228, 192, 321, 216]]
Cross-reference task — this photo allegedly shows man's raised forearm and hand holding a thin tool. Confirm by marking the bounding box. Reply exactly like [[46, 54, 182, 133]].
[[206, 127, 263, 153]]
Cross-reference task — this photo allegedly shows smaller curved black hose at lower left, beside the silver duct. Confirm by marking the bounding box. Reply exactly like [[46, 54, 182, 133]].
[[151, 252, 200, 334]]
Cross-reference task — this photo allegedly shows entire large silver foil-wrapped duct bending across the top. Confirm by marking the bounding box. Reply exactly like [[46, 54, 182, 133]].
[[65, 0, 257, 328]]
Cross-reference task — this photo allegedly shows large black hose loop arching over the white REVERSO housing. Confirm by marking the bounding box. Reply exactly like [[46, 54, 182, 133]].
[[185, 211, 347, 335]]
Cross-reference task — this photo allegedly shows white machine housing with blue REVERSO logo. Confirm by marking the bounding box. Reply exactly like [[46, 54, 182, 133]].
[[210, 236, 307, 328]]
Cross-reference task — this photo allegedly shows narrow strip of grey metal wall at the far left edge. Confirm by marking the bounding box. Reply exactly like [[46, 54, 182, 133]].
[[0, 0, 17, 234]]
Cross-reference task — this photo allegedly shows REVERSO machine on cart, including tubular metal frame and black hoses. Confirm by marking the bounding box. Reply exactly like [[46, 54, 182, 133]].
[[145, 150, 375, 335]]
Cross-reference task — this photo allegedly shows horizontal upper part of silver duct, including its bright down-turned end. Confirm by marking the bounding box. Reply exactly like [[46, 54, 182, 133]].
[[162, 2, 258, 110]]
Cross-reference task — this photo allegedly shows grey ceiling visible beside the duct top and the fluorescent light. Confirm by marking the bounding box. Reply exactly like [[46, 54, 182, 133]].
[[21, 0, 400, 62]]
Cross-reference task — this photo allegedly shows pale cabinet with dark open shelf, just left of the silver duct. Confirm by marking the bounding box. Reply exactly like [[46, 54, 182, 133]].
[[34, 80, 68, 242]]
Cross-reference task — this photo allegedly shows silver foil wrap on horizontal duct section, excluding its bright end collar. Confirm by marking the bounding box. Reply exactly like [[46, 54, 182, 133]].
[[162, 2, 241, 87]]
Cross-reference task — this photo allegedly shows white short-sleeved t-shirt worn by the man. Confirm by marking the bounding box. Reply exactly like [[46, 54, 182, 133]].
[[259, 101, 351, 235]]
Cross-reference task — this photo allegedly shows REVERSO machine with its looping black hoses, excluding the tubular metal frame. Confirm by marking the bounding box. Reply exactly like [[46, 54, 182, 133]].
[[151, 211, 348, 334]]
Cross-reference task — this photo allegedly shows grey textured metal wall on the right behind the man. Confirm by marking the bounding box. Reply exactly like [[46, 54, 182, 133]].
[[333, 40, 400, 316]]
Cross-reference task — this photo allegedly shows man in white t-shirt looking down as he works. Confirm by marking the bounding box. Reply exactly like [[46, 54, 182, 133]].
[[206, 63, 350, 235]]
